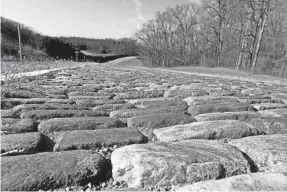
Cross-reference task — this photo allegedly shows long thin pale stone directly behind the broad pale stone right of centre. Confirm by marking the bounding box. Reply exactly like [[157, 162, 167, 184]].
[[194, 111, 260, 122]]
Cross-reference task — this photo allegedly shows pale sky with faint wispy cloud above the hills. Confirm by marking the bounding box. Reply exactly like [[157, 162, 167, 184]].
[[0, 0, 198, 39]]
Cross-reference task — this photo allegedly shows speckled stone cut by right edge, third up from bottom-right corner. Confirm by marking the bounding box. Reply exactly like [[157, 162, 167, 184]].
[[251, 118, 287, 135]]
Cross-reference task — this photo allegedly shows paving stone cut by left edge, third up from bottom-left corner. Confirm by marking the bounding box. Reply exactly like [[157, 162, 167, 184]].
[[1, 118, 37, 134]]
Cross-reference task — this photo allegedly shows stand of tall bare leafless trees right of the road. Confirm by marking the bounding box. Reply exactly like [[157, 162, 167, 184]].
[[135, 0, 287, 74]]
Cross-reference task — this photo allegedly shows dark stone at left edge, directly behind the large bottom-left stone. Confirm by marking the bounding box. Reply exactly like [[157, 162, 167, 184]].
[[1, 132, 45, 154]]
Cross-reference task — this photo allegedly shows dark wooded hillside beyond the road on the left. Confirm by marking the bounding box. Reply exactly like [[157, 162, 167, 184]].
[[1, 17, 138, 60]]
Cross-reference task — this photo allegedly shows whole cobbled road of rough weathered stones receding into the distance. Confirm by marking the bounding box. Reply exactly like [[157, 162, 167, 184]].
[[1, 58, 287, 191]]
